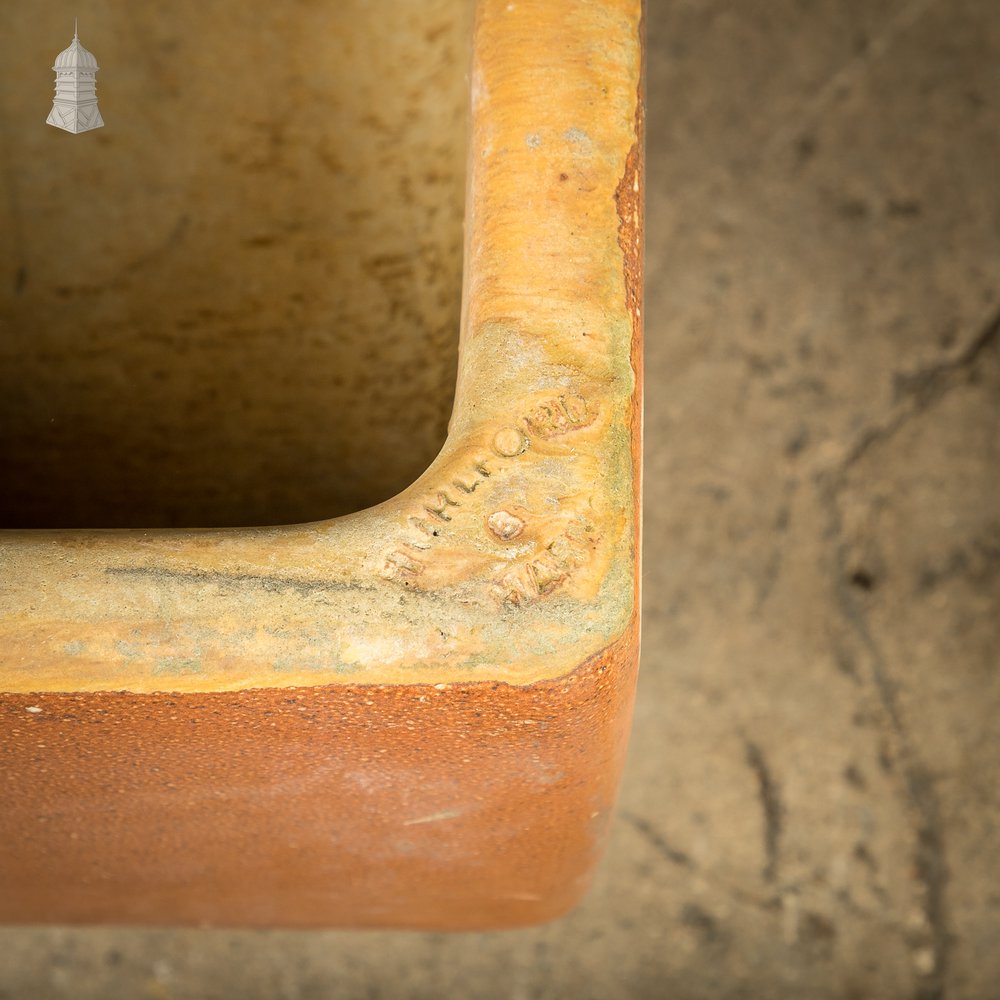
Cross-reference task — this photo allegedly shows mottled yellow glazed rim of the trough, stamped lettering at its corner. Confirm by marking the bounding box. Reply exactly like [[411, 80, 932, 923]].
[[0, 0, 642, 693]]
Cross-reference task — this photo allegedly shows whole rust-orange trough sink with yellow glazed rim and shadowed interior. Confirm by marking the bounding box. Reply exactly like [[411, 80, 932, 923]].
[[0, 0, 642, 928]]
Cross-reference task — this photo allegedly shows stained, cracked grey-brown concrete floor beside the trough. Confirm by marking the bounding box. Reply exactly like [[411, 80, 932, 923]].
[[0, 0, 1000, 1000]]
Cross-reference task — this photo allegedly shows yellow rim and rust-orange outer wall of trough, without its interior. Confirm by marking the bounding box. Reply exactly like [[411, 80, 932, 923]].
[[0, 0, 642, 928]]
